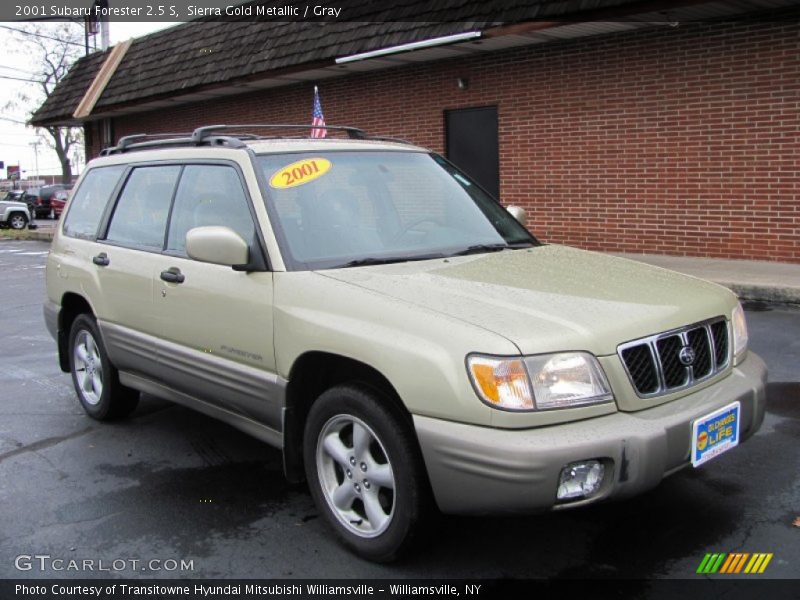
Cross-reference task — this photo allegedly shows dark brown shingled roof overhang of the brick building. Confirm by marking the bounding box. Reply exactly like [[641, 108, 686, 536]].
[[30, 0, 799, 126]]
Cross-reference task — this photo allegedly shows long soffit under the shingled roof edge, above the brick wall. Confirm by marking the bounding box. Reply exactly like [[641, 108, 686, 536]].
[[92, 0, 798, 119]]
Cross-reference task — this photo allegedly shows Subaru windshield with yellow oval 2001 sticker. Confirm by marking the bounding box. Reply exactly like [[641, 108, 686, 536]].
[[258, 150, 538, 270]]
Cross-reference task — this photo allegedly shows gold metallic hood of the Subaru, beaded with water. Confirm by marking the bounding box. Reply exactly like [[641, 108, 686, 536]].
[[319, 245, 736, 356]]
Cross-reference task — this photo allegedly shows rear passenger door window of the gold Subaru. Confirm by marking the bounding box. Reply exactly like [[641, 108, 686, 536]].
[[106, 166, 181, 250]]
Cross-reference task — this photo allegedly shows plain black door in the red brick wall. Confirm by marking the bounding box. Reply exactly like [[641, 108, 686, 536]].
[[445, 106, 500, 198]]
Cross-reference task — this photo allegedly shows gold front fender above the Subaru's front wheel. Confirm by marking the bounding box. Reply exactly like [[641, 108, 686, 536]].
[[275, 271, 519, 425]]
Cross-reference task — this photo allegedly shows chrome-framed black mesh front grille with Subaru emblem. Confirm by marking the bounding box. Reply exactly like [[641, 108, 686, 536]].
[[617, 317, 729, 398]]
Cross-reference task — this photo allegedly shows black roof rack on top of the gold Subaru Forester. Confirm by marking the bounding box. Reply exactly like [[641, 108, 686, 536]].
[[100, 124, 410, 156]]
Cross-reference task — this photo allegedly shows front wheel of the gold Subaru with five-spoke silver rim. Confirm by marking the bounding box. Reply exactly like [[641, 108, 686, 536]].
[[303, 384, 435, 562]]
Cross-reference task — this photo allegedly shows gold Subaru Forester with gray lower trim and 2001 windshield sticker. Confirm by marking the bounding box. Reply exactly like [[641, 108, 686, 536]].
[[44, 126, 766, 561]]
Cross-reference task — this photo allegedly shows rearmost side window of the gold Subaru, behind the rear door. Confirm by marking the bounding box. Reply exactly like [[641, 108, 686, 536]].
[[64, 165, 125, 240]]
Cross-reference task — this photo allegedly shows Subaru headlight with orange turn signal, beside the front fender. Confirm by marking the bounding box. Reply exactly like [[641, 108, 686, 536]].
[[467, 352, 614, 410]]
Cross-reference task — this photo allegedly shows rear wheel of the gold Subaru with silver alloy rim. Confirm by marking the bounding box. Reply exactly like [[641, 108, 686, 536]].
[[67, 314, 139, 421]]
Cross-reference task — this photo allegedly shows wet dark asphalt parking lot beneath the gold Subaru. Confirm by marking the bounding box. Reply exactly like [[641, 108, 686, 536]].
[[0, 242, 800, 578]]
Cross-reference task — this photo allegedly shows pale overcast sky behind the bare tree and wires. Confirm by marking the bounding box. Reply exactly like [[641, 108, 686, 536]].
[[0, 22, 175, 185]]
